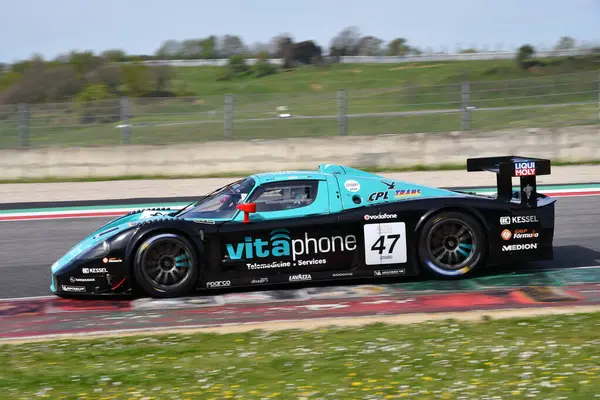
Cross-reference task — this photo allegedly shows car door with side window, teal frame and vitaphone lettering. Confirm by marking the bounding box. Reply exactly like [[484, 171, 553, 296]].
[[219, 179, 357, 278]]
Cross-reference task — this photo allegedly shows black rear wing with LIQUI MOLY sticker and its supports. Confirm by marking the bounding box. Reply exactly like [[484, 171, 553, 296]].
[[467, 156, 550, 207]]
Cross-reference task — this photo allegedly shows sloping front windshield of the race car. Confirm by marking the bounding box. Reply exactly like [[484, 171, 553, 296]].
[[178, 178, 256, 219]]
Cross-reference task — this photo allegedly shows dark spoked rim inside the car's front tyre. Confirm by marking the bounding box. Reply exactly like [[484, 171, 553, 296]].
[[141, 239, 193, 291]]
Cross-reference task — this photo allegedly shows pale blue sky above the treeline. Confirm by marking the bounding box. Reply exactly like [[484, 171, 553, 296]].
[[0, 0, 600, 62]]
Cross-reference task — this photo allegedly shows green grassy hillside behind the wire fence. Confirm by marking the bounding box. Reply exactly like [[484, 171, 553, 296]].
[[0, 58, 600, 148]]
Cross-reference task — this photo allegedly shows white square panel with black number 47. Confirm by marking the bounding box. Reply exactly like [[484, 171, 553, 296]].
[[364, 222, 406, 265]]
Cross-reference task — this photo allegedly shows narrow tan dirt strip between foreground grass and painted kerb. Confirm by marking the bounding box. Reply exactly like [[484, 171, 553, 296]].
[[0, 305, 600, 344]]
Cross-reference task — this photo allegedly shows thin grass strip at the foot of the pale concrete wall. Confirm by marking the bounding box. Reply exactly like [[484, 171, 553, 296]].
[[0, 160, 600, 184]]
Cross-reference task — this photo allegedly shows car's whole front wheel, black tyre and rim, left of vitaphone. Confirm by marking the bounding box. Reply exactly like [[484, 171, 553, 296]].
[[133, 233, 199, 298]]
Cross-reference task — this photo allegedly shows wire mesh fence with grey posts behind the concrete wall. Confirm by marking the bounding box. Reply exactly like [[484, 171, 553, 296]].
[[0, 72, 600, 148]]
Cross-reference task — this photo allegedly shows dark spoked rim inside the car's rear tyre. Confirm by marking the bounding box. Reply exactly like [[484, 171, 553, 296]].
[[427, 219, 477, 271]]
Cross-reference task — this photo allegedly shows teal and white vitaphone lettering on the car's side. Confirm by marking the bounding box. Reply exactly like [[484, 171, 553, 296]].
[[225, 229, 356, 261]]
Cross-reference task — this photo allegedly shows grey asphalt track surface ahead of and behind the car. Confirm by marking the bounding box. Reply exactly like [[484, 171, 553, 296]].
[[0, 196, 600, 299]]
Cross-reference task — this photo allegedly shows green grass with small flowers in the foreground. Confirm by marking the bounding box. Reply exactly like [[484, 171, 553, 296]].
[[0, 313, 600, 400]]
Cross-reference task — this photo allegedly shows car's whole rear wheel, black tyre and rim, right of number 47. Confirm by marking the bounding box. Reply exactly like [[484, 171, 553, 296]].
[[418, 211, 487, 279]]
